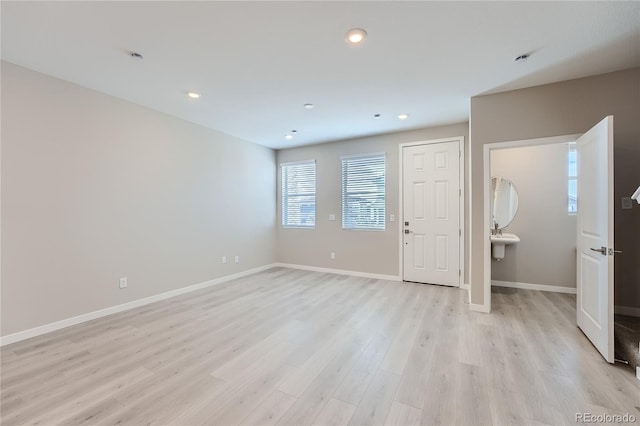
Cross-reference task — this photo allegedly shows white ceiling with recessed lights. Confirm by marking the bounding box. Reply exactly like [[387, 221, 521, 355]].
[[1, 1, 640, 149]]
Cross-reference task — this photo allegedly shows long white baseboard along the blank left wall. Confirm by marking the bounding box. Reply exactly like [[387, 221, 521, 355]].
[[0, 264, 277, 346]]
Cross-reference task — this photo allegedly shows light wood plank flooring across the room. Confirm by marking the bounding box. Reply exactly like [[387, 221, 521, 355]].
[[1, 268, 640, 426]]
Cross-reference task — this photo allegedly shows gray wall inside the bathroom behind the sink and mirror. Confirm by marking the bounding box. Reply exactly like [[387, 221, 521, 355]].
[[491, 143, 577, 287]]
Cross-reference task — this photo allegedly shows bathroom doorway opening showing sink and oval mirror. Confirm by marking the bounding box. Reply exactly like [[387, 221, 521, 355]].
[[490, 142, 577, 294]]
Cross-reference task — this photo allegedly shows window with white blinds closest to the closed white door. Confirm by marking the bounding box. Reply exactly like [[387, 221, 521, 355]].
[[342, 154, 386, 230]]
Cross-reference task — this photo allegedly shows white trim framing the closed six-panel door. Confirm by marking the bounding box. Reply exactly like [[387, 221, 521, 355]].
[[397, 136, 466, 287]]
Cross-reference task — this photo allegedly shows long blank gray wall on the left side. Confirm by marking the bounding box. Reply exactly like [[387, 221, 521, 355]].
[[1, 62, 276, 335]]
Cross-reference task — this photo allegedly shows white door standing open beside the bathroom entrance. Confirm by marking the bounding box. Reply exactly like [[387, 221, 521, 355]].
[[576, 116, 614, 363]]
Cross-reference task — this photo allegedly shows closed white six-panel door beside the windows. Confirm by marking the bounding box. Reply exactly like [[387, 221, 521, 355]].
[[402, 141, 462, 287]]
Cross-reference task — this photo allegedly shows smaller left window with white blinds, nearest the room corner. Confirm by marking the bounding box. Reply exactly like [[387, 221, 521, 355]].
[[281, 161, 316, 228]]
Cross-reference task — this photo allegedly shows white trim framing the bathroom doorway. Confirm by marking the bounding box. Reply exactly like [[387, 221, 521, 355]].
[[478, 134, 580, 312]]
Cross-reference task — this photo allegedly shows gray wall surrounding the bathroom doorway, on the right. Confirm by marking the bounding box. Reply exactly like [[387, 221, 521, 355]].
[[469, 68, 640, 307]]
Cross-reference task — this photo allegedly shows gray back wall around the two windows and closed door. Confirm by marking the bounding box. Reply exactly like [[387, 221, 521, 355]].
[[277, 123, 469, 282]]
